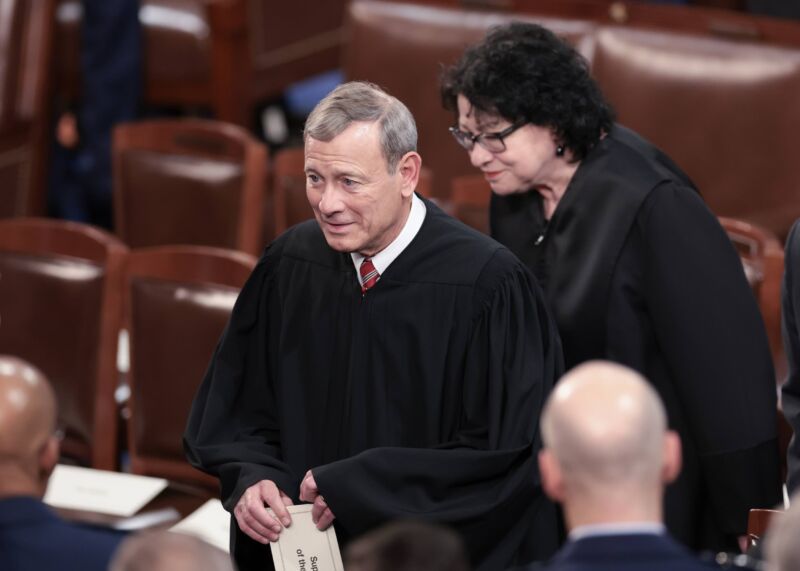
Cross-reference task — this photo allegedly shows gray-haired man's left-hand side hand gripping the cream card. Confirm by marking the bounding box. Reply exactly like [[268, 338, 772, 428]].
[[233, 480, 292, 543]]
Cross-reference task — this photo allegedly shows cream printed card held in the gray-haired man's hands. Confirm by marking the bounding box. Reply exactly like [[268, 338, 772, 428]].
[[269, 504, 344, 571]]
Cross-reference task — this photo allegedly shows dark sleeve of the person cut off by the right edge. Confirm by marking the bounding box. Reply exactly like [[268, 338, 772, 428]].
[[781, 222, 800, 493]]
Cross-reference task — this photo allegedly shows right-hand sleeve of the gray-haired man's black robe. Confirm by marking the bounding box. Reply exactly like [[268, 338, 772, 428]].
[[313, 249, 562, 569]]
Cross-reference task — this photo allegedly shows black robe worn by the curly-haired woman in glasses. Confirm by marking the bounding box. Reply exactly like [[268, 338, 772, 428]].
[[491, 125, 780, 550]]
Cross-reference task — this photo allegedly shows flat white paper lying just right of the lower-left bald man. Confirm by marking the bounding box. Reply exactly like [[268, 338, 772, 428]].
[[44, 464, 167, 517]]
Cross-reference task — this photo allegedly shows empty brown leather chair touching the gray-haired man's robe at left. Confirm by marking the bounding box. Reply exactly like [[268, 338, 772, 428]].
[[125, 246, 256, 489]]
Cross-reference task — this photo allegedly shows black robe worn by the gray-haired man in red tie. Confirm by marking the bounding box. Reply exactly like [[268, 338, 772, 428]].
[[185, 202, 563, 571]]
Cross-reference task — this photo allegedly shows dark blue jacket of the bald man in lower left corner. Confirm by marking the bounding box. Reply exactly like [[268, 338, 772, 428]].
[[0, 497, 125, 571]]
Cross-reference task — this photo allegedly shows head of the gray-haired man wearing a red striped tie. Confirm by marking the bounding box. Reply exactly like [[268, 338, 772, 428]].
[[303, 82, 421, 256]]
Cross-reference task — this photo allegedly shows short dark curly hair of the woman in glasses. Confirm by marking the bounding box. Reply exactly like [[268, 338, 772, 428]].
[[441, 22, 614, 160]]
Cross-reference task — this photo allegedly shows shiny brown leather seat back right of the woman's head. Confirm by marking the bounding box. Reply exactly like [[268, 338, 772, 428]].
[[592, 27, 800, 239]]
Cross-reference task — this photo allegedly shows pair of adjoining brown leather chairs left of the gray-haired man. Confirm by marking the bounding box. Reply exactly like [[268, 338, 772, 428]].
[[0, 218, 256, 488]]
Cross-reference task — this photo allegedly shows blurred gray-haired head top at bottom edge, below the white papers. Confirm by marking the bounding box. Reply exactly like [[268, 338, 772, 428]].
[[109, 531, 235, 571]]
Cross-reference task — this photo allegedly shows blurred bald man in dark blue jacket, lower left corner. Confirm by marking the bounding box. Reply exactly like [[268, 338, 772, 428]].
[[0, 356, 124, 571]]
